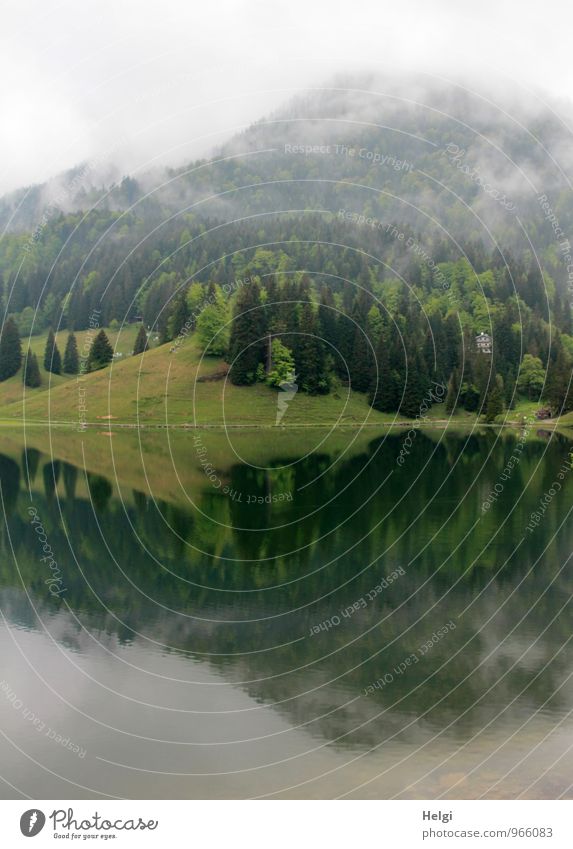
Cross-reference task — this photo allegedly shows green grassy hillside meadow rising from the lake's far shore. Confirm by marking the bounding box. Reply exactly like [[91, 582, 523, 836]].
[[0, 328, 395, 427]]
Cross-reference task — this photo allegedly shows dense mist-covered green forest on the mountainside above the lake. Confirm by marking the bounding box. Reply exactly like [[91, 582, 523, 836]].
[[0, 83, 573, 421]]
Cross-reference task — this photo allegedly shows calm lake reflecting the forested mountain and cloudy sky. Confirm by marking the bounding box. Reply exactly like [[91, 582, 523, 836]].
[[0, 426, 573, 799]]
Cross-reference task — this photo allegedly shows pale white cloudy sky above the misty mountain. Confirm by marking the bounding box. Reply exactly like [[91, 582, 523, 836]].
[[0, 0, 573, 192]]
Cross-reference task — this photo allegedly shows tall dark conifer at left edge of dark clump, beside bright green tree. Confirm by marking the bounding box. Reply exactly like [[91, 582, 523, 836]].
[[229, 280, 266, 386]]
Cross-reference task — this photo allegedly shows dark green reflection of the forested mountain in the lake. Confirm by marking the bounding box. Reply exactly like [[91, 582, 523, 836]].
[[0, 431, 573, 797]]
